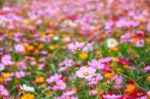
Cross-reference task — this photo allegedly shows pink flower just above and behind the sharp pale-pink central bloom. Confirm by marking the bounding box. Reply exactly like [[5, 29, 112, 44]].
[[88, 60, 105, 70]]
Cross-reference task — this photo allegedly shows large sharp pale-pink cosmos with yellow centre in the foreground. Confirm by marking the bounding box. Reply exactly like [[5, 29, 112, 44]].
[[76, 66, 96, 79]]
